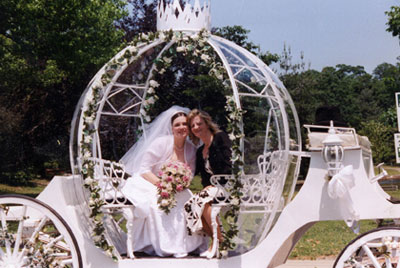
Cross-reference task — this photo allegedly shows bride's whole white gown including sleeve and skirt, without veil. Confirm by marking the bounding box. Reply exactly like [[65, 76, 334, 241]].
[[122, 136, 207, 257]]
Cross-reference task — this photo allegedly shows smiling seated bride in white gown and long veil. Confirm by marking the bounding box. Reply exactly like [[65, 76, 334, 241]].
[[121, 106, 207, 257]]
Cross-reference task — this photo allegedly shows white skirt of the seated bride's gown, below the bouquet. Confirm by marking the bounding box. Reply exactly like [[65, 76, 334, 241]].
[[122, 175, 207, 257]]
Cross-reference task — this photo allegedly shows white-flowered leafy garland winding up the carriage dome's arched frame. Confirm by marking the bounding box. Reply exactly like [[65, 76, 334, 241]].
[[81, 30, 243, 260]]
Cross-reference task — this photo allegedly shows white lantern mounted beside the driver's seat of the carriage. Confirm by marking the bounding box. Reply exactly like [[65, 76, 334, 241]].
[[322, 121, 344, 177]]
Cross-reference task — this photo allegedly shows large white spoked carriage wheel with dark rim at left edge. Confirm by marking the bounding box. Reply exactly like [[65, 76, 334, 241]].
[[0, 195, 83, 268]]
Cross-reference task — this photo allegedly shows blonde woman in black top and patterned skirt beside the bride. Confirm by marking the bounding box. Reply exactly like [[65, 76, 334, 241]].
[[185, 109, 232, 257]]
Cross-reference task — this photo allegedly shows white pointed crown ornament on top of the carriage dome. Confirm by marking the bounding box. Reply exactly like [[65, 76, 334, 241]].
[[157, 0, 211, 31]]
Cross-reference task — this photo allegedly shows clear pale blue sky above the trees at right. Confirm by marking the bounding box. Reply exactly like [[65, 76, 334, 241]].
[[211, 0, 400, 73]]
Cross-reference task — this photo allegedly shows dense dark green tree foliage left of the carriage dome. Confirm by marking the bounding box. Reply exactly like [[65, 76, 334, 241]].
[[0, 0, 125, 180]]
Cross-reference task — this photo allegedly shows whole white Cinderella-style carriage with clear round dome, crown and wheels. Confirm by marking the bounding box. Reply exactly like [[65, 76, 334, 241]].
[[0, 0, 400, 268]]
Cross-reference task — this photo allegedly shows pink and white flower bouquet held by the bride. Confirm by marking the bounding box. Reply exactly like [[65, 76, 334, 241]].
[[157, 161, 192, 214]]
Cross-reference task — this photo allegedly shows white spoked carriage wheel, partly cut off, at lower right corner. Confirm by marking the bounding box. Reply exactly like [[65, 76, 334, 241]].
[[333, 227, 400, 268]]
